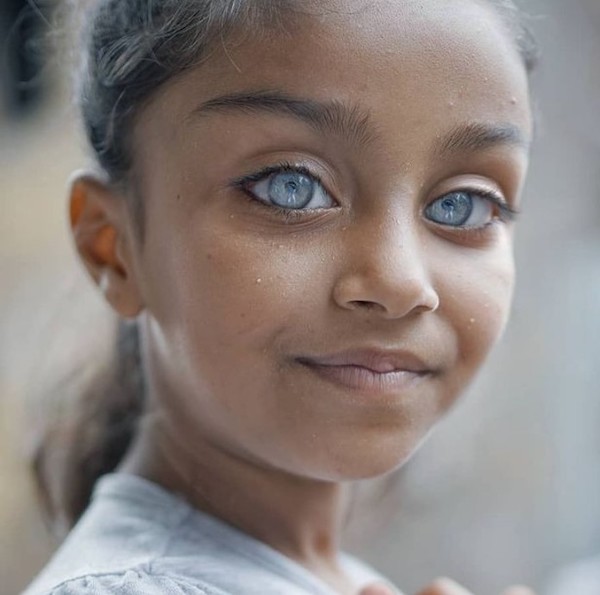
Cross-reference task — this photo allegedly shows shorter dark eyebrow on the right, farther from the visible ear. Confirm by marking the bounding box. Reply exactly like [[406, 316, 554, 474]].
[[434, 123, 531, 157]]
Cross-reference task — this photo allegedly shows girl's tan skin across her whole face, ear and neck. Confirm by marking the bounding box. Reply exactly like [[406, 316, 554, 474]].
[[71, 0, 531, 595]]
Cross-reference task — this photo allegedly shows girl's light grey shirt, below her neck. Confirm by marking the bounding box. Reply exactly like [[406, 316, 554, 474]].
[[23, 473, 401, 595]]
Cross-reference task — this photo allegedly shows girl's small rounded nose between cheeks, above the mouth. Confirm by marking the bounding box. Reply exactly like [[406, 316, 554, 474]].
[[333, 222, 440, 319]]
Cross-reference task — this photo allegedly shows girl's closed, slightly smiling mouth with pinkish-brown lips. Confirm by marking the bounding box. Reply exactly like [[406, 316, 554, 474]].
[[297, 349, 434, 395]]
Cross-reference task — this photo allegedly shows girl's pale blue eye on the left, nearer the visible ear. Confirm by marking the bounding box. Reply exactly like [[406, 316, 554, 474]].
[[236, 165, 336, 211]]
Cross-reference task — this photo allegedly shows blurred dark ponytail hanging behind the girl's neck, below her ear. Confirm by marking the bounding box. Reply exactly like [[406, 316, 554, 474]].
[[33, 321, 144, 533]]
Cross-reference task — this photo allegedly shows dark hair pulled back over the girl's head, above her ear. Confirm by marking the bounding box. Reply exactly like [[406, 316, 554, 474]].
[[79, 0, 298, 180]]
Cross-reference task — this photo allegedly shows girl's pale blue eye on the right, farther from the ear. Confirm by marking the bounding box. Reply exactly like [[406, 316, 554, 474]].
[[424, 190, 516, 229]]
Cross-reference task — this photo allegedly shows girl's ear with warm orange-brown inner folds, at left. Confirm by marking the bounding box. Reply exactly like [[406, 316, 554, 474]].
[[69, 173, 144, 318]]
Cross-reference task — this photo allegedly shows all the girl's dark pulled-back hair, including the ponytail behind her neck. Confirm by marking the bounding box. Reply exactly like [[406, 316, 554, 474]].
[[35, 0, 535, 526]]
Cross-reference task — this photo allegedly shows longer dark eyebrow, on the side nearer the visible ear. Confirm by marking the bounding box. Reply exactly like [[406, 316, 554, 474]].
[[192, 91, 375, 145]]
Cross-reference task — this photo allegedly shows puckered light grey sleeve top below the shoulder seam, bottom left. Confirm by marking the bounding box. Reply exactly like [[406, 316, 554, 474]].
[[30, 570, 229, 595]]
